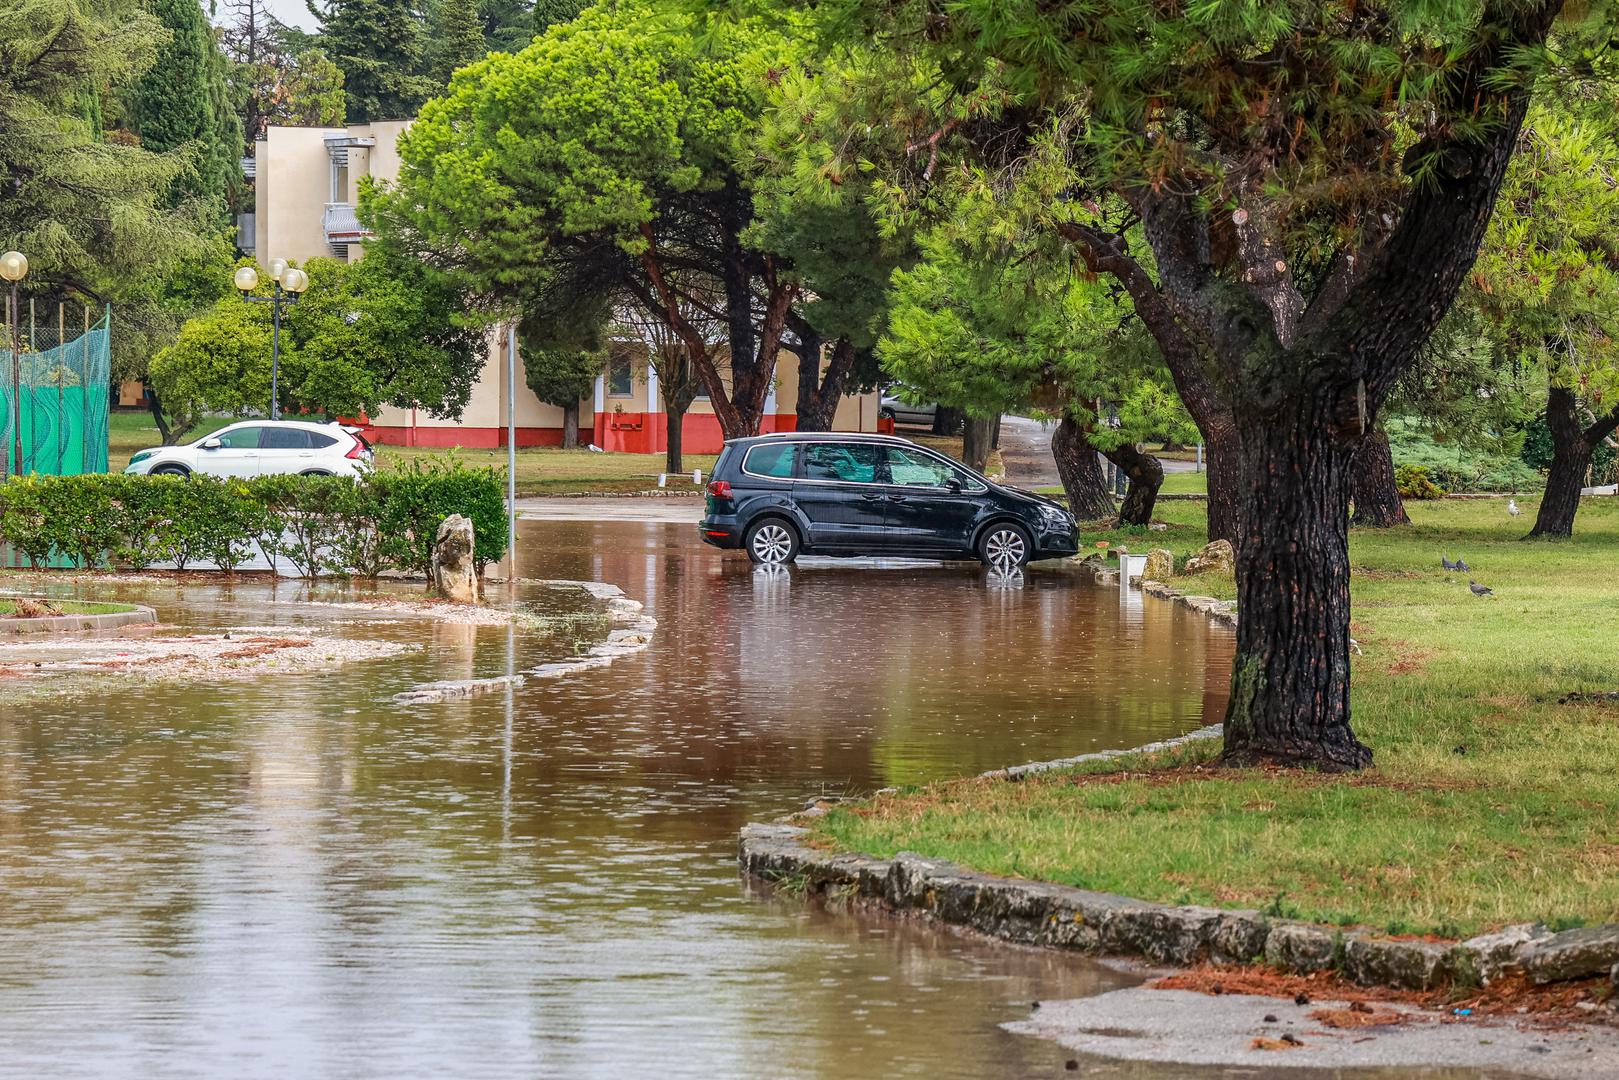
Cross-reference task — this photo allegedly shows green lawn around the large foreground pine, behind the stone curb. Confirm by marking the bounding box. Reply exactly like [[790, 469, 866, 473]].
[[816, 499, 1619, 934]]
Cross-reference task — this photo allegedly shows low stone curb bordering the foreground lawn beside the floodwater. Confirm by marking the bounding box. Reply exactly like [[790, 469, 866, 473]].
[[737, 824, 1619, 989]]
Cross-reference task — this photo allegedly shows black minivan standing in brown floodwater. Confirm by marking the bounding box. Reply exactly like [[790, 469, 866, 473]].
[[699, 432, 1078, 568]]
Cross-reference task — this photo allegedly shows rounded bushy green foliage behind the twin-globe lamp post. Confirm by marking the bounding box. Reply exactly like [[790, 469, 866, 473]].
[[152, 251, 484, 416]]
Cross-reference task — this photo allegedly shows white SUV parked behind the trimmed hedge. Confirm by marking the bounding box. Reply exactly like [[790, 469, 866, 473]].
[[123, 419, 372, 476]]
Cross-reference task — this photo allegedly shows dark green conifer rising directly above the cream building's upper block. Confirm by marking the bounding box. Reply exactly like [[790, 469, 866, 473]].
[[310, 0, 437, 123]]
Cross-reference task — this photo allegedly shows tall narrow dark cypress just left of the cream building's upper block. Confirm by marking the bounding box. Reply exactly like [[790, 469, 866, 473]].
[[130, 0, 241, 202]]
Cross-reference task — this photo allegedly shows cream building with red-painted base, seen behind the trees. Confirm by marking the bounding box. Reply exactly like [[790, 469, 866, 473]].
[[241, 120, 877, 453]]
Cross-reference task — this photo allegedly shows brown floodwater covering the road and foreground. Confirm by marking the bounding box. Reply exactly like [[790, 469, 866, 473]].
[[0, 521, 1483, 1078]]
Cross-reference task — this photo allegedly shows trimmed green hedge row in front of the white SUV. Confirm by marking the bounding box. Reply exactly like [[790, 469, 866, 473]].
[[0, 460, 507, 576]]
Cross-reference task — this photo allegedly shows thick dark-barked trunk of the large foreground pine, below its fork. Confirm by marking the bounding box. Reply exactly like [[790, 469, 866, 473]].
[[1226, 414, 1371, 771]]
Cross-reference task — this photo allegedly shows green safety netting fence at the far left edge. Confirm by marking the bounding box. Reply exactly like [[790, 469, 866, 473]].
[[0, 311, 112, 476]]
